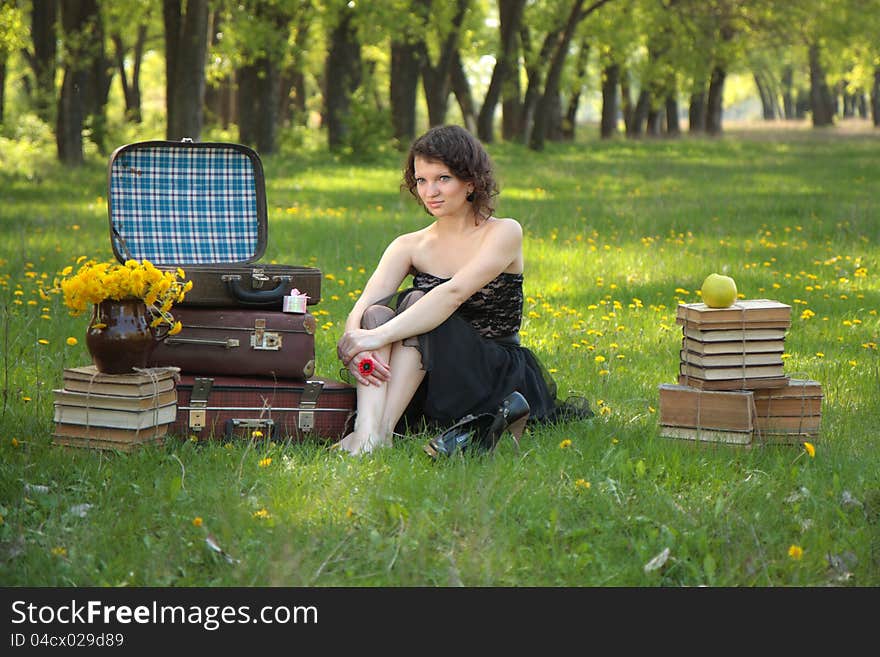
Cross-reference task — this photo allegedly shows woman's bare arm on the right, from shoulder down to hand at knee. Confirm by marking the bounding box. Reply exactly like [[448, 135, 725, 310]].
[[338, 220, 522, 359]]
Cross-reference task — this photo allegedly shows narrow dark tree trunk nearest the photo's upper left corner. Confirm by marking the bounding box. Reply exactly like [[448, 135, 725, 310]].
[[25, 0, 57, 124]]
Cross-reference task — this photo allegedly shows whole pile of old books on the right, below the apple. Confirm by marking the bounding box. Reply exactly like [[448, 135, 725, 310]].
[[659, 299, 822, 445]]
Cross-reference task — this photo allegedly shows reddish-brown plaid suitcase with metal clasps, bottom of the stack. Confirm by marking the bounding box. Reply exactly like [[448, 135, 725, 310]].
[[169, 374, 357, 442]]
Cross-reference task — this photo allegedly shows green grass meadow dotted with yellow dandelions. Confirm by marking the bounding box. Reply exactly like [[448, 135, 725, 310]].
[[0, 123, 880, 586]]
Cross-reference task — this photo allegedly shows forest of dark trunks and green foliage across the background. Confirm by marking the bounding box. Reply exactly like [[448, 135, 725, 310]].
[[0, 0, 880, 165]]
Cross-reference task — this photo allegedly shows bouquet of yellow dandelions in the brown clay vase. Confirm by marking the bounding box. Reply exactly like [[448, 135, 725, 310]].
[[61, 256, 193, 335]]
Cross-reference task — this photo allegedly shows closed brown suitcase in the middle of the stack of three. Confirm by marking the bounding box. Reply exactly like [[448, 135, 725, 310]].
[[148, 306, 315, 381]]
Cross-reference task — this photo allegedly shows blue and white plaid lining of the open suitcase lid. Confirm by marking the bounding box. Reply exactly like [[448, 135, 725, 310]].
[[110, 147, 259, 265]]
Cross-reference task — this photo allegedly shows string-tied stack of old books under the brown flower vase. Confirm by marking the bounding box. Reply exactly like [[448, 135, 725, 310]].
[[52, 365, 178, 452]]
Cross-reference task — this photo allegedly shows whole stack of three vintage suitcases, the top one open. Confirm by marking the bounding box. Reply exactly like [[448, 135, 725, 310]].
[[108, 140, 356, 441]]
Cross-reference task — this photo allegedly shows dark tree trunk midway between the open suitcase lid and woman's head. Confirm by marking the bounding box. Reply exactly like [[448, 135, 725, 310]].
[[324, 6, 361, 151]]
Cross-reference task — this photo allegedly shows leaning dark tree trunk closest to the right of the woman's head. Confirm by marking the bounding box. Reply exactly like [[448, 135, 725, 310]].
[[477, 0, 526, 144]]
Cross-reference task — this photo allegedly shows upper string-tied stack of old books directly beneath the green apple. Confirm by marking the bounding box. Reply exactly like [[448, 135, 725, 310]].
[[675, 299, 791, 391]]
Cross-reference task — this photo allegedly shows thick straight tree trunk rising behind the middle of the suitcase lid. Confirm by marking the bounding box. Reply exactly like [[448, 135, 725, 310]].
[[162, 0, 209, 141]]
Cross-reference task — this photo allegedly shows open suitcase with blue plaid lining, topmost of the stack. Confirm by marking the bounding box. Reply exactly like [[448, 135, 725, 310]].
[[107, 140, 321, 311]]
